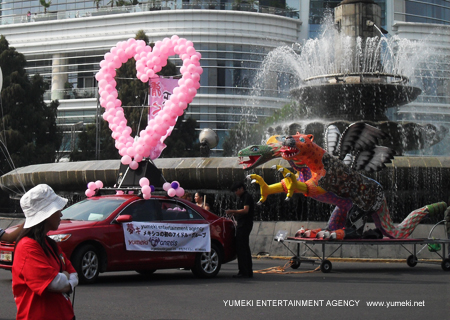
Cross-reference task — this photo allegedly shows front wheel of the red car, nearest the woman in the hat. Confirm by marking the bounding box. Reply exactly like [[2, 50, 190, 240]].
[[72, 244, 100, 284]]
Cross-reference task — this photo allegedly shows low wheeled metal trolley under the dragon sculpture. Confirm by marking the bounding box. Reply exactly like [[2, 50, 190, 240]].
[[274, 231, 450, 273]]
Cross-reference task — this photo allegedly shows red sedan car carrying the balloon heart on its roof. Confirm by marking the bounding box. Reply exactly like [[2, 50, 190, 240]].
[[0, 195, 236, 283]]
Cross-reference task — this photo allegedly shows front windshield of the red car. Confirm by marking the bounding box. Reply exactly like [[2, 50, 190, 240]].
[[62, 198, 126, 221]]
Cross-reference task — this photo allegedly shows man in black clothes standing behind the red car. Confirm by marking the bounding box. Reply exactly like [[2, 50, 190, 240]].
[[225, 182, 254, 278]]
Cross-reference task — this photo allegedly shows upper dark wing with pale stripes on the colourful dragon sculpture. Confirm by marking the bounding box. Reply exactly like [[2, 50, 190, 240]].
[[339, 122, 387, 160]]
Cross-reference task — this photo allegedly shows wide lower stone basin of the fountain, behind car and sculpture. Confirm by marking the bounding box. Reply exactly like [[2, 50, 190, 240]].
[[0, 157, 450, 223]]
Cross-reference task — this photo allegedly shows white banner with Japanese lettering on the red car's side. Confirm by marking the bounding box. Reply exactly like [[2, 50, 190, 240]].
[[123, 222, 211, 252]]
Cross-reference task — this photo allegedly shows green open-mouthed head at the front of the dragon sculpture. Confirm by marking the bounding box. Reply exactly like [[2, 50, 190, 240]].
[[238, 136, 282, 170]]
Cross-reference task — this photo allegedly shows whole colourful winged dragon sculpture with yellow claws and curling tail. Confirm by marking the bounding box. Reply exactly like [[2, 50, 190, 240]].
[[238, 122, 447, 238]]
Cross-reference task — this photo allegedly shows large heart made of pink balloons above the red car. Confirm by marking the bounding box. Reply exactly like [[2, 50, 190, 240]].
[[95, 35, 203, 170]]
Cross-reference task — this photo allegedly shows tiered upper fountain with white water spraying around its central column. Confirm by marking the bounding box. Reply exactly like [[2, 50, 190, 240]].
[[260, 0, 447, 155]]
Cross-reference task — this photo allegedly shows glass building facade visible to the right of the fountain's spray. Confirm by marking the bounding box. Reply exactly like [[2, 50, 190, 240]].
[[390, 0, 450, 155]]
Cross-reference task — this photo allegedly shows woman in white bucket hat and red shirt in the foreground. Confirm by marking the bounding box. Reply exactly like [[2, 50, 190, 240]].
[[12, 184, 78, 320]]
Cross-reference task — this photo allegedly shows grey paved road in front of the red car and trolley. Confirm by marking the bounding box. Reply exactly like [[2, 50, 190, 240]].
[[0, 259, 450, 320]]
